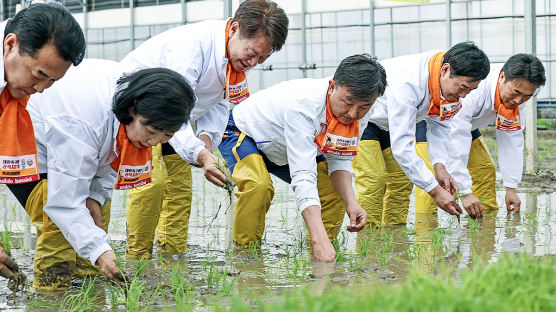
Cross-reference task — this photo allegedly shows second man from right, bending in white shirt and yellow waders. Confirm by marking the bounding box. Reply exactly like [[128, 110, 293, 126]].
[[354, 42, 490, 226]]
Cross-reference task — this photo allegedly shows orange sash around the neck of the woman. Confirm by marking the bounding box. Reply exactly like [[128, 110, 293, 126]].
[[110, 124, 152, 190]]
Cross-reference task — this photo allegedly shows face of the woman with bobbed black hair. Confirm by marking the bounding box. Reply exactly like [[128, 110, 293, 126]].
[[125, 113, 174, 148]]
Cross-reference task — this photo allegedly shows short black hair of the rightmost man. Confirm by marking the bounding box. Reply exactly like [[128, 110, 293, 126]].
[[501, 53, 546, 87]]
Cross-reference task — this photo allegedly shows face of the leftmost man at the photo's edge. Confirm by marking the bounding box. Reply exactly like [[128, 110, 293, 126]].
[[4, 33, 71, 98]]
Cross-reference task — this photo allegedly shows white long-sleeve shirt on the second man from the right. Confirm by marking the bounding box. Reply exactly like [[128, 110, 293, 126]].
[[367, 51, 457, 192]]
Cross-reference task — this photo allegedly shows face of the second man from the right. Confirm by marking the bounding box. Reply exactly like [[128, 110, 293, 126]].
[[440, 63, 481, 102]]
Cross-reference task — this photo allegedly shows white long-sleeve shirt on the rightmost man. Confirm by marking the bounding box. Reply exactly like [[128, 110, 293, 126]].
[[448, 64, 526, 194]]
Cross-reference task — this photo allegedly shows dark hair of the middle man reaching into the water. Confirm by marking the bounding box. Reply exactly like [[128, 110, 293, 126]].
[[334, 53, 387, 101]]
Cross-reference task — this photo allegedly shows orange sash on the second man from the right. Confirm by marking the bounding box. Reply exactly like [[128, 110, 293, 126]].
[[427, 52, 461, 121]]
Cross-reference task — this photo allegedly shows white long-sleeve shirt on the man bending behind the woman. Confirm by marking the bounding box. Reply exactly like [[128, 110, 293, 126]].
[[120, 20, 229, 163]]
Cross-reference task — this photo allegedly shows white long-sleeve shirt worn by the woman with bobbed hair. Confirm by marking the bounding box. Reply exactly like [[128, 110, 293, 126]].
[[27, 59, 121, 264]]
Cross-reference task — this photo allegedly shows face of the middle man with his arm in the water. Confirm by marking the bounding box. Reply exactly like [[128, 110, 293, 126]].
[[328, 80, 377, 125]]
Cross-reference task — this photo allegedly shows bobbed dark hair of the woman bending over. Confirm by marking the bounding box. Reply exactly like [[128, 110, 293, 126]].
[[112, 68, 195, 133]]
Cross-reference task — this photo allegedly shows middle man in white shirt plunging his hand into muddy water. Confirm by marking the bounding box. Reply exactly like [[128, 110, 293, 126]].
[[219, 54, 386, 261]]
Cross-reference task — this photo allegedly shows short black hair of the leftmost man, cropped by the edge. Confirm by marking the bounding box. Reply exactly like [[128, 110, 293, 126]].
[[4, 3, 86, 66]]
